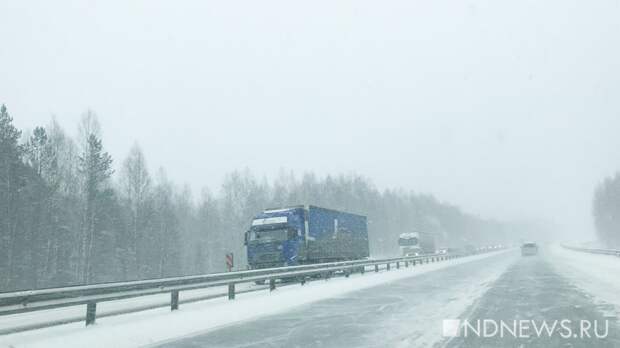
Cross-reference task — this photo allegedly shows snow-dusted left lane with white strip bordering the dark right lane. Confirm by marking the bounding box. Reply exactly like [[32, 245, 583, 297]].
[[153, 251, 517, 347]]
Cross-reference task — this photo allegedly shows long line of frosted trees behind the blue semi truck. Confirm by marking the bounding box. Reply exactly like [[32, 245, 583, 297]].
[[0, 105, 516, 291]]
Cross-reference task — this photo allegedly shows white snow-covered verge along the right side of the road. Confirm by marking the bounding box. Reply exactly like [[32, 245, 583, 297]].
[[548, 245, 620, 316]]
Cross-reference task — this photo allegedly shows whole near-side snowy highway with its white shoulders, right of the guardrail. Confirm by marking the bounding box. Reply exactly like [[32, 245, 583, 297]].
[[0, 246, 620, 348]]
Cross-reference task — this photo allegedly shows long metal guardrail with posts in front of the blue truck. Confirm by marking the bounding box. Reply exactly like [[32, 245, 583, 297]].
[[0, 250, 494, 325]]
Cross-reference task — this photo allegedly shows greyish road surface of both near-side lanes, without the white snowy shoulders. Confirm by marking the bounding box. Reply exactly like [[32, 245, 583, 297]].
[[153, 252, 620, 348]]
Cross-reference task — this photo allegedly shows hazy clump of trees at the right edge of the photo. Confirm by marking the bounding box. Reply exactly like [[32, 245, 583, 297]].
[[592, 173, 620, 248]]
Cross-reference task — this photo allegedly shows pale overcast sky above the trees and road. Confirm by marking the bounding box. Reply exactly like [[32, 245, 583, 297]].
[[0, 0, 620, 238]]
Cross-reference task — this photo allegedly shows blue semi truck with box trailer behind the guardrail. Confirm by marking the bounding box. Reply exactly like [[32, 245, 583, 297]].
[[245, 205, 369, 269]]
